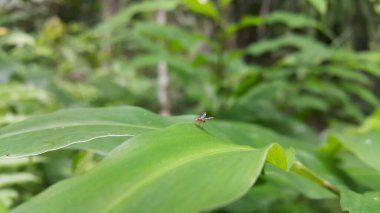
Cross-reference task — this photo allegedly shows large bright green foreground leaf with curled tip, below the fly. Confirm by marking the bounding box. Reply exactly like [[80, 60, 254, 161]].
[[13, 124, 287, 213]]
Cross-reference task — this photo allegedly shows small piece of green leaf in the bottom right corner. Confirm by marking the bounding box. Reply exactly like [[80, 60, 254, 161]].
[[340, 189, 380, 213]]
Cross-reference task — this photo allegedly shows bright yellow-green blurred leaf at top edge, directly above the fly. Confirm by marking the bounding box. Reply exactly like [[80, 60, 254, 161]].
[[185, 0, 219, 19]]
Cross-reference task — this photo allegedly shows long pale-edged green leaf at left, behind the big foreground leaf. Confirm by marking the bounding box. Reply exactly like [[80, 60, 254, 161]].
[[0, 107, 171, 157]]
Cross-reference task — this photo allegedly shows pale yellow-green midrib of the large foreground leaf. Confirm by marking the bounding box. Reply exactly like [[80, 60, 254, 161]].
[[103, 147, 254, 212]]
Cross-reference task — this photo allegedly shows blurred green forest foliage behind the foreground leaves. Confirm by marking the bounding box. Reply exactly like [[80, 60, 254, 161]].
[[0, 0, 380, 212]]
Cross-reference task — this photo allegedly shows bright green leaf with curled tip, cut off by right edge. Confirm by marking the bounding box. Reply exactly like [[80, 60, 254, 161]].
[[322, 111, 380, 190]]
